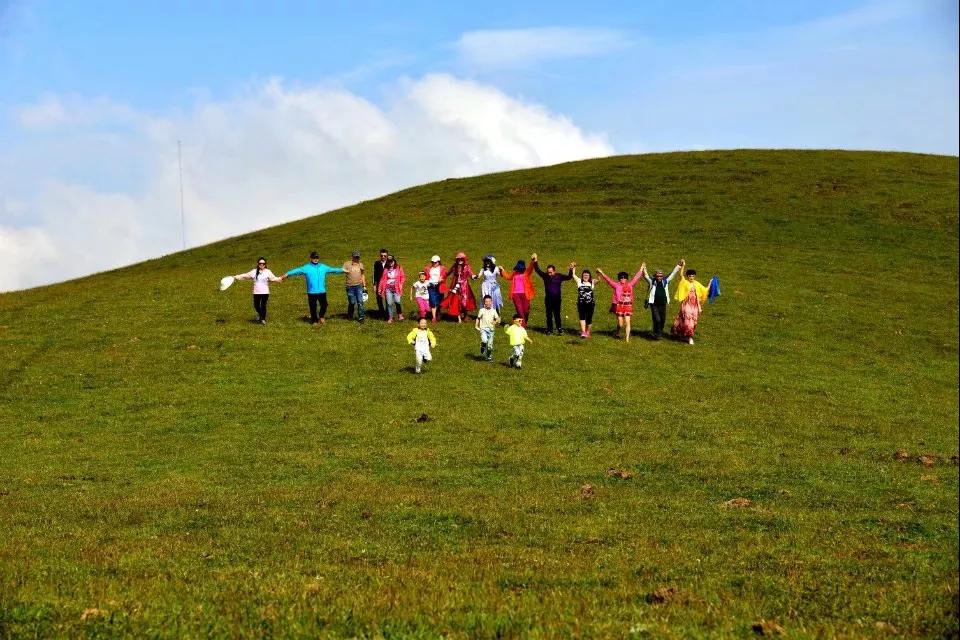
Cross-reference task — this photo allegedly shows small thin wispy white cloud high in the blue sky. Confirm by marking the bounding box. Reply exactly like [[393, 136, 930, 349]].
[[456, 27, 631, 67]]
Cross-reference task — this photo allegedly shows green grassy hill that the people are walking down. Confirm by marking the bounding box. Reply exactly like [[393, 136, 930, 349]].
[[0, 151, 958, 638]]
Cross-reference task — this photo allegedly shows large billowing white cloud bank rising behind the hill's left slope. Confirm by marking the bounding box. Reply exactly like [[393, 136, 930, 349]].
[[0, 75, 614, 290]]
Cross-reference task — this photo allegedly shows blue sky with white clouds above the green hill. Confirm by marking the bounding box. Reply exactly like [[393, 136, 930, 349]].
[[0, 0, 958, 286]]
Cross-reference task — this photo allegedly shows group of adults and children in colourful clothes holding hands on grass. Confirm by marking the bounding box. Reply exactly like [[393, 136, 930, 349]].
[[233, 249, 720, 372]]
